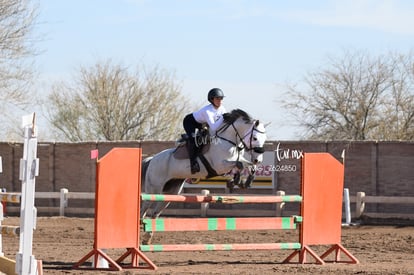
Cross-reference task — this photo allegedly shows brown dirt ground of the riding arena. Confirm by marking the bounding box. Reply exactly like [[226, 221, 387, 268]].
[[3, 217, 414, 274]]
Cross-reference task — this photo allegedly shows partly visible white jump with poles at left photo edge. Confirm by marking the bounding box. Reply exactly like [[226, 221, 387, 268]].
[[0, 114, 42, 275]]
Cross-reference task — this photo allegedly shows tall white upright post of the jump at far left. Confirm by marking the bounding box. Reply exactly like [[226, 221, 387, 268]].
[[16, 113, 39, 275]]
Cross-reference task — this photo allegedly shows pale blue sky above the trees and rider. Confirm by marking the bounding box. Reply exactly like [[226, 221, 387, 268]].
[[36, 0, 414, 140]]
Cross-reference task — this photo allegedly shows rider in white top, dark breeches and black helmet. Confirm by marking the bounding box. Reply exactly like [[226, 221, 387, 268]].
[[183, 88, 226, 174]]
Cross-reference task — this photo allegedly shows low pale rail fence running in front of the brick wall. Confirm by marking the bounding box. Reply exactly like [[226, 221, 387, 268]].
[[0, 188, 414, 219]]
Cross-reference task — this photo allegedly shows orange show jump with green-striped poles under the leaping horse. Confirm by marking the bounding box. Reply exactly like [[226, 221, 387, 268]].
[[73, 148, 359, 271]]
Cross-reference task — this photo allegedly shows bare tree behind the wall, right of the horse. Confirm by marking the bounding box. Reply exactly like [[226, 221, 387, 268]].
[[283, 51, 414, 140]]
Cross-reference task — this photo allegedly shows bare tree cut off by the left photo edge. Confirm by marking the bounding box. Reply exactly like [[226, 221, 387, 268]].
[[0, 0, 37, 138]]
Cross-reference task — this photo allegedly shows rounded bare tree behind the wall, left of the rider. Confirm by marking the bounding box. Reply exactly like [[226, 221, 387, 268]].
[[49, 61, 189, 141]]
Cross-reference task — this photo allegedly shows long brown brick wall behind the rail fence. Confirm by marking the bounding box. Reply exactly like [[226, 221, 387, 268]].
[[0, 141, 414, 216]]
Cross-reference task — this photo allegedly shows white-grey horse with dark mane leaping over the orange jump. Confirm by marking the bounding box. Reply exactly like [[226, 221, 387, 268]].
[[141, 109, 266, 243]]
